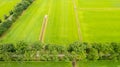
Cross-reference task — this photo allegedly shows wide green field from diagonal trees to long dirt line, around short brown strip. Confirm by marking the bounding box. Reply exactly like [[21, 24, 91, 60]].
[[1, 0, 79, 44]]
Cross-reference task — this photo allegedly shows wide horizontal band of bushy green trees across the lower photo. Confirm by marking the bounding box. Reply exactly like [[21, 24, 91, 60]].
[[0, 41, 120, 61]]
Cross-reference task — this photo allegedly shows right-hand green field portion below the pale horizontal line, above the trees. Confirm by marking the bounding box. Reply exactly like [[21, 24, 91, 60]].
[[82, 10, 120, 42]]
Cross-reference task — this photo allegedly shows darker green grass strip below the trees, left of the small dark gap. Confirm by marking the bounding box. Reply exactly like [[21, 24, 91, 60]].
[[0, 61, 72, 67]]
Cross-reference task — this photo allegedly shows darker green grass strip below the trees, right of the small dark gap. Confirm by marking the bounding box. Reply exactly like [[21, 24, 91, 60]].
[[77, 60, 120, 67]]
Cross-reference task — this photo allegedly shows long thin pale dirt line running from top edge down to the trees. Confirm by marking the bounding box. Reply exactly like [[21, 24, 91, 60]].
[[72, 0, 82, 42]]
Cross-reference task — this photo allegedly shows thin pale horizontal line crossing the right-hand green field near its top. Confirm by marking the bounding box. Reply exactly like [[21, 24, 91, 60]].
[[77, 8, 120, 11]]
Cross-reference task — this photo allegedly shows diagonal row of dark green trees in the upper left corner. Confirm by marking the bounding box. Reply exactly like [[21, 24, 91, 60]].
[[0, 0, 34, 36]]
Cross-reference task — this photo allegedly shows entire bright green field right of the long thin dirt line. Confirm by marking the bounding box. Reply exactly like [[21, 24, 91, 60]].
[[76, 0, 120, 42]]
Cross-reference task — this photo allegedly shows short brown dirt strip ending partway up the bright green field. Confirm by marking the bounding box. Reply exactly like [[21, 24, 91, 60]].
[[39, 15, 48, 43]]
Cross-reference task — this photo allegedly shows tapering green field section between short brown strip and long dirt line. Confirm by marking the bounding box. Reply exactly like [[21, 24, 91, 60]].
[[45, 0, 79, 44]]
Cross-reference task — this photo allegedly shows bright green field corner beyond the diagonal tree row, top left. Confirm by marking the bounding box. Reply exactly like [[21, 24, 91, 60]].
[[0, 0, 21, 20]]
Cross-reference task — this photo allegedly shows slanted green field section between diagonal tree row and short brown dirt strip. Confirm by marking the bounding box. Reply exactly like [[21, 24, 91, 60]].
[[1, 0, 49, 42]]
